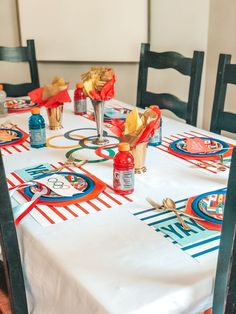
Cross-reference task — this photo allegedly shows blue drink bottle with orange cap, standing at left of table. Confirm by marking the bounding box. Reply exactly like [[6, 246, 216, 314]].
[[29, 107, 46, 148]]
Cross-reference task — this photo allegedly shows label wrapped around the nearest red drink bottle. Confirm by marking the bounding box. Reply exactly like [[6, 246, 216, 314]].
[[113, 169, 134, 191]]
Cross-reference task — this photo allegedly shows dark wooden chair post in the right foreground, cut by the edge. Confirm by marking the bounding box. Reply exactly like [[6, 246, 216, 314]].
[[213, 148, 236, 314]]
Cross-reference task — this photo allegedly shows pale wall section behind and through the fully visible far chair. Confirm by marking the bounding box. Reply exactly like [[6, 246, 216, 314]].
[[149, 0, 209, 126]]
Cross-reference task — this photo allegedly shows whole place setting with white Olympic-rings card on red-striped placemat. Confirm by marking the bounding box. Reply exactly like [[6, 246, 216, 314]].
[[7, 156, 132, 227]]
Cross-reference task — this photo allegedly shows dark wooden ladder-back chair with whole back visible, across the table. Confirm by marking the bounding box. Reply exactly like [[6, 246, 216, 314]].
[[136, 44, 204, 125]]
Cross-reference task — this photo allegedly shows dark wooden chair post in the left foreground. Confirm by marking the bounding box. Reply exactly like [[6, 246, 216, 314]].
[[0, 153, 28, 314]]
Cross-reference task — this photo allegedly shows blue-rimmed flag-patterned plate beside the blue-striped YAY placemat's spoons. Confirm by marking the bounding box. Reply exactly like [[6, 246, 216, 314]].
[[192, 190, 226, 224]]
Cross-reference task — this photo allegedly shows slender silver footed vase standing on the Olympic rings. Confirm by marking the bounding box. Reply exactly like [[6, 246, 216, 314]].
[[91, 99, 109, 145]]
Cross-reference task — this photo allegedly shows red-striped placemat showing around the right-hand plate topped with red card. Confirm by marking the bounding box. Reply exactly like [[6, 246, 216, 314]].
[[156, 131, 229, 174]]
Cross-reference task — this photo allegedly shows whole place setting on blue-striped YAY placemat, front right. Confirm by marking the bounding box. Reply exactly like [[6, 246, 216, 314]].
[[127, 188, 226, 261]]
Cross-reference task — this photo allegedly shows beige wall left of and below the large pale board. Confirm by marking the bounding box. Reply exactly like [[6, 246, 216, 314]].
[[0, 0, 138, 105]]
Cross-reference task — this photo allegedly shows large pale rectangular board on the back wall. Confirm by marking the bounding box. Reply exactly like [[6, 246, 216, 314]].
[[18, 0, 148, 63]]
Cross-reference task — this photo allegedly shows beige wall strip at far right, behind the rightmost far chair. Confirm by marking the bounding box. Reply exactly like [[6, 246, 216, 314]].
[[204, 0, 236, 135]]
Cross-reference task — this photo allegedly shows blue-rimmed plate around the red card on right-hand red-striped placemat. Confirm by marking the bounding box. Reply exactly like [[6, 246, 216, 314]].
[[170, 137, 229, 157]]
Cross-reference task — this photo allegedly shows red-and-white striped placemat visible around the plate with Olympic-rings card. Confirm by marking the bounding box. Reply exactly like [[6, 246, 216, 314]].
[[7, 162, 133, 226]]
